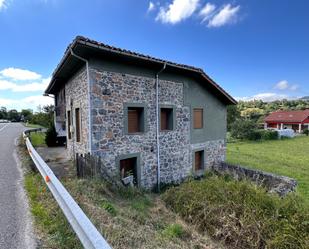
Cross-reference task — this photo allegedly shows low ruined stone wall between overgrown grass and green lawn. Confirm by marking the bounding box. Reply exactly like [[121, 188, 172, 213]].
[[213, 162, 297, 196]]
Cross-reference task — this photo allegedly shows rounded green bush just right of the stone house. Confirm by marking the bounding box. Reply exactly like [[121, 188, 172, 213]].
[[231, 119, 257, 139]]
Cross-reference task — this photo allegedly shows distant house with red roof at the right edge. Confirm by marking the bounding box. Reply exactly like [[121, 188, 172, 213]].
[[264, 110, 309, 133]]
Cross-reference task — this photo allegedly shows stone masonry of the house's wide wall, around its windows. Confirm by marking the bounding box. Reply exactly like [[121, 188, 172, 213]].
[[87, 68, 225, 189]]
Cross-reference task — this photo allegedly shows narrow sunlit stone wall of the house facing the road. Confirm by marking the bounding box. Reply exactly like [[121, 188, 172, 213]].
[[65, 67, 89, 157]]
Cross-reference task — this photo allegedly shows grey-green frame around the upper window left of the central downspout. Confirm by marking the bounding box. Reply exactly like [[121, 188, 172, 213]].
[[123, 103, 147, 135]]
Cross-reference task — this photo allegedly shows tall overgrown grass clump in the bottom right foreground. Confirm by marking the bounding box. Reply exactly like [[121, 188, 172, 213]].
[[163, 176, 309, 249]]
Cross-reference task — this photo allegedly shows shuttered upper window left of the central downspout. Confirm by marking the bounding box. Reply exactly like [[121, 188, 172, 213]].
[[124, 104, 146, 134]]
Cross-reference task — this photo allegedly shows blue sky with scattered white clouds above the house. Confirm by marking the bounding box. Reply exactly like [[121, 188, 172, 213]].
[[0, 0, 309, 110]]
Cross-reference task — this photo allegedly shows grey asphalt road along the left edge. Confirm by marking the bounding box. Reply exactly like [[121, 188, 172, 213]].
[[0, 123, 35, 249]]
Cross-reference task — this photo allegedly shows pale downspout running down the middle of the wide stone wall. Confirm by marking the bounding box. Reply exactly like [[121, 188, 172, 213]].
[[156, 62, 166, 192]]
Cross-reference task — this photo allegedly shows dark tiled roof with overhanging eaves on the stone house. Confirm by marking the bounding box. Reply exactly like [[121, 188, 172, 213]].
[[45, 36, 237, 104]]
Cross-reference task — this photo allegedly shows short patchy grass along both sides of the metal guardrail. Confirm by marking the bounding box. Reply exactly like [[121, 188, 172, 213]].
[[19, 137, 223, 249]]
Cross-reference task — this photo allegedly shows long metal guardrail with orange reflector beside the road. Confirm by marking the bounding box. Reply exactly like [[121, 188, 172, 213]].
[[23, 129, 111, 249]]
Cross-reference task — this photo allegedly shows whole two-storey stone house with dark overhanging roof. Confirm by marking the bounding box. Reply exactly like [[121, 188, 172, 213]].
[[45, 36, 236, 189]]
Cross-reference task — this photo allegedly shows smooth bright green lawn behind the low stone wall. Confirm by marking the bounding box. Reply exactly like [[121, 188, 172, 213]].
[[227, 136, 309, 203]]
